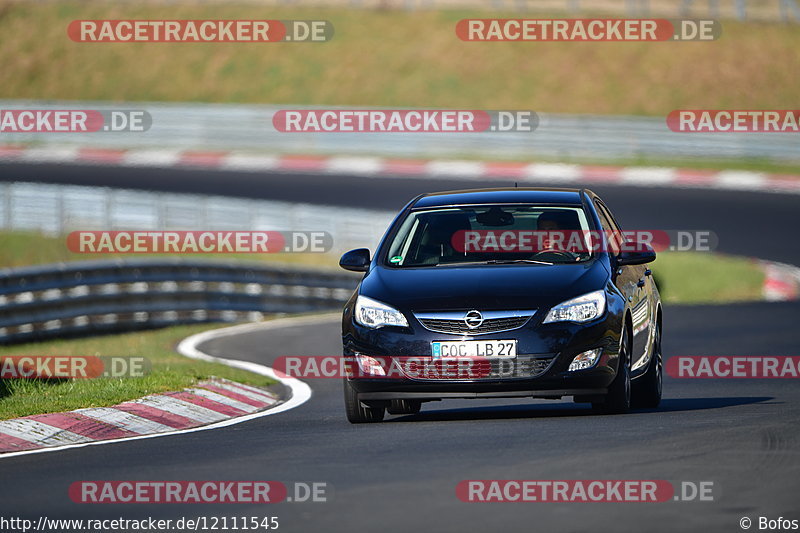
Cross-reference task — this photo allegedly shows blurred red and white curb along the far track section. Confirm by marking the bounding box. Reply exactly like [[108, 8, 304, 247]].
[[0, 145, 800, 194]]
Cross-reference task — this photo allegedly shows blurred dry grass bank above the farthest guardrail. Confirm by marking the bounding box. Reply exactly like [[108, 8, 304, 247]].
[[0, 1, 800, 116]]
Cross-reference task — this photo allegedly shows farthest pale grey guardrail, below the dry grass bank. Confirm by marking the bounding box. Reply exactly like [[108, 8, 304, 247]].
[[0, 100, 800, 162]]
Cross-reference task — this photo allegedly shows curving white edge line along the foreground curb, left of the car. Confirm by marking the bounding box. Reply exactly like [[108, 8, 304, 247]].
[[0, 313, 332, 459]]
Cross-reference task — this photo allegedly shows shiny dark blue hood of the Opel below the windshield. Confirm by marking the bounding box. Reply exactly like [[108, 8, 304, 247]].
[[360, 260, 608, 311]]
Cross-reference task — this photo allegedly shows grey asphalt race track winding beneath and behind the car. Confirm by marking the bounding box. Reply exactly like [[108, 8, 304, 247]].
[[0, 165, 800, 532]]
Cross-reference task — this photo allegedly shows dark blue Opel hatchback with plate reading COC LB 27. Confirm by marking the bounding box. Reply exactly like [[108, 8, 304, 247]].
[[340, 188, 662, 423]]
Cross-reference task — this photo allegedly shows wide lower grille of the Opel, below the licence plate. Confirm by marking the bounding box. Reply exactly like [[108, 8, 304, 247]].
[[405, 354, 556, 381]]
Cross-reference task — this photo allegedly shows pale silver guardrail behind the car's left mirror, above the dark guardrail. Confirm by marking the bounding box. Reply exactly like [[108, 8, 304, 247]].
[[0, 182, 394, 255]]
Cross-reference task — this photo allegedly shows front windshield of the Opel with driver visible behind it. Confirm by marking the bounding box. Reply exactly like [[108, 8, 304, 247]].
[[385, 205, 591, 268]]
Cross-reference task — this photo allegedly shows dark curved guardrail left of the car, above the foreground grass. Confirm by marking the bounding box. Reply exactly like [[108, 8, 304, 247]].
[[0, 260, 358, 344]]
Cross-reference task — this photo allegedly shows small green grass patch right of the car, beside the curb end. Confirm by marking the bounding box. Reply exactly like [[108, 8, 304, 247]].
[[652, 252, 764, 304]]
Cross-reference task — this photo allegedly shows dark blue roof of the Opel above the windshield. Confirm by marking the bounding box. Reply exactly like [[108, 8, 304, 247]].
[[412, 187, 596, 209]]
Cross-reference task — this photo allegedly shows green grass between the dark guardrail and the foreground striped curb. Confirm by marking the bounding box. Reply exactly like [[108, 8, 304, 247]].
[[0, 324, 274, 419]]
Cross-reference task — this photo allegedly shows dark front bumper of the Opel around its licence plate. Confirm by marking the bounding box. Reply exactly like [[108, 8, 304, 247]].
[[342, 304, 622, 401]]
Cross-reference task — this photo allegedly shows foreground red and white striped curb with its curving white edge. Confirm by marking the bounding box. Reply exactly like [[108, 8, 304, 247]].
[[0, 314, 324, 459]]
